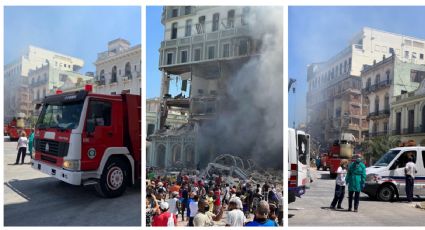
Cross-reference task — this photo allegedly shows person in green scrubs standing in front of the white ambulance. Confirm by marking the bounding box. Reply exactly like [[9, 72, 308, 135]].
[[345, 156, 366, 212]]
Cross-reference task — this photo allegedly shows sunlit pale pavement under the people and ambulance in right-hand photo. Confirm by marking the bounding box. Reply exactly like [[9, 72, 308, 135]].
[[289, 168, 425, 227]]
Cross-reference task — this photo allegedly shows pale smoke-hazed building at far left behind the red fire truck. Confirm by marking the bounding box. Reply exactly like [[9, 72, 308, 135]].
[[4, 46, 84, 122]]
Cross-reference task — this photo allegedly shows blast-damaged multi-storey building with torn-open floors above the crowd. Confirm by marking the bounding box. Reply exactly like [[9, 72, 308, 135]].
[[147, 6, 282, 168]]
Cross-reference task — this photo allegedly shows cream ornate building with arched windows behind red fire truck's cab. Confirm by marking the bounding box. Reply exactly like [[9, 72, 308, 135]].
[[94, 38, 142, 95]]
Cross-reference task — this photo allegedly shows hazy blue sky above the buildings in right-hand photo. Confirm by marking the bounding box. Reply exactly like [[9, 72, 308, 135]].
[[288, 6, 425, 127]]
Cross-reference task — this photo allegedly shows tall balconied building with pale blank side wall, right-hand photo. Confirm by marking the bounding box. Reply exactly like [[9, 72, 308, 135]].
[[361, 55, 425, 137]]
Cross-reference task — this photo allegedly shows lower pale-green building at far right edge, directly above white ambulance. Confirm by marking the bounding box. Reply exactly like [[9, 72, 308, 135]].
[[391, 79, 425, 146]]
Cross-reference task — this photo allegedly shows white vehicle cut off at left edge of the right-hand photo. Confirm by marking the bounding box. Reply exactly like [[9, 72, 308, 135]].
[[288, 129, 310, 203]]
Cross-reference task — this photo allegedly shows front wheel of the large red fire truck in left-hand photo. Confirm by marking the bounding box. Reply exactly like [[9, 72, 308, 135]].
[[96, 159, 128, 198]]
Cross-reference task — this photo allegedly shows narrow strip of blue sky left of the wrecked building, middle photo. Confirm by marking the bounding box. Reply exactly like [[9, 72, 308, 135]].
[[146, 6, 162, 98]]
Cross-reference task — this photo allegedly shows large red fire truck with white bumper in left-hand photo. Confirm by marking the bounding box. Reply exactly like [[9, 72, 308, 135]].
[[31, 86, 141, 197]]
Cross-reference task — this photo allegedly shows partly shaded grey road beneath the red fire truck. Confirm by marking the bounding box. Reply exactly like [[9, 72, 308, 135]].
[[4, 142, 141, 226]]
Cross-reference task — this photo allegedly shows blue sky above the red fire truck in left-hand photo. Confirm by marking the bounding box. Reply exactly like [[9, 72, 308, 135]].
[[4, 6, 141, 73]]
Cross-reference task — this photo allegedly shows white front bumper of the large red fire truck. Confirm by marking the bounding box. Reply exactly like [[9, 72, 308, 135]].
[[31, 160, 83, 185]]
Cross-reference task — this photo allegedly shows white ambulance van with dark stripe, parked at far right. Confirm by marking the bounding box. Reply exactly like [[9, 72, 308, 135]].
[[363, 146, 425, 201]]
